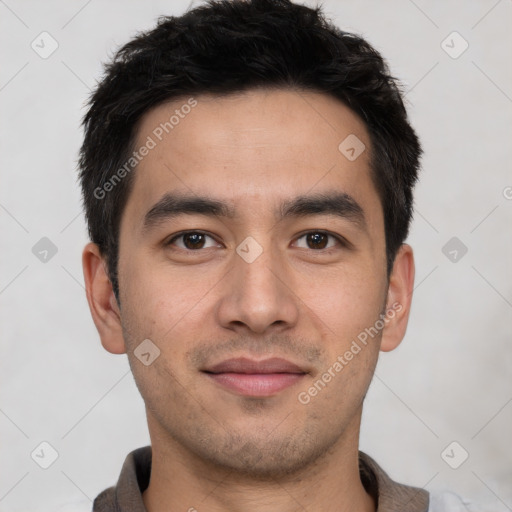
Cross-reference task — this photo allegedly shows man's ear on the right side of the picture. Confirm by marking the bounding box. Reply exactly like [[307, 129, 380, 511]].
[[380, 244, 414, 352]]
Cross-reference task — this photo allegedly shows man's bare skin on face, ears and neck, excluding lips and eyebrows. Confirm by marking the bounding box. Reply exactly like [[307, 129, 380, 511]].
[[83, 89, 414, 512]]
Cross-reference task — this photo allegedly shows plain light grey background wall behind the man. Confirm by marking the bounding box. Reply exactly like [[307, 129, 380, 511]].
[[0, 0, 512, 512]]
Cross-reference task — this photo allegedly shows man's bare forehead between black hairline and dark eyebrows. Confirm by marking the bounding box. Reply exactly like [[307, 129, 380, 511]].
[[121, 89, 380, 231]]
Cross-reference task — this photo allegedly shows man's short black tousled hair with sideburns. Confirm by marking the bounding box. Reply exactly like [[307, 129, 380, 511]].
[[78, 0, 421, 302]]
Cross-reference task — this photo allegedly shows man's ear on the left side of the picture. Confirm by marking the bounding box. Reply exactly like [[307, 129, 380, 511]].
[[82, 242, 126, 354]]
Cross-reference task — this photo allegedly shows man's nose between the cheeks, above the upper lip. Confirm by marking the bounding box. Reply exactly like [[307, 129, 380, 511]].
[[217, 240, 300, 334]]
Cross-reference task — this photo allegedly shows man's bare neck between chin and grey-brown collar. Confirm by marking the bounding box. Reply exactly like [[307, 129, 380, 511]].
[[143, 415, 376, 512]]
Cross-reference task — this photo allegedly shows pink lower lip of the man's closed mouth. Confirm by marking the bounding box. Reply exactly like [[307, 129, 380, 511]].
[[207, 373, 305, 396]]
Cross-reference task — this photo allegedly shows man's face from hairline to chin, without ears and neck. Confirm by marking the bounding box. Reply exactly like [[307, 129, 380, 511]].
[[101, 90, 396, 476]]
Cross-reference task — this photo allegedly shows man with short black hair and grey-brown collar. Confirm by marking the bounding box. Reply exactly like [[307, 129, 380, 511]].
[[80, 0, 462, 512]]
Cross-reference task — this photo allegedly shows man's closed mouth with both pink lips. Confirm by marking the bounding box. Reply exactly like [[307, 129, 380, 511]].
[[202, 358, 308, 397]]
